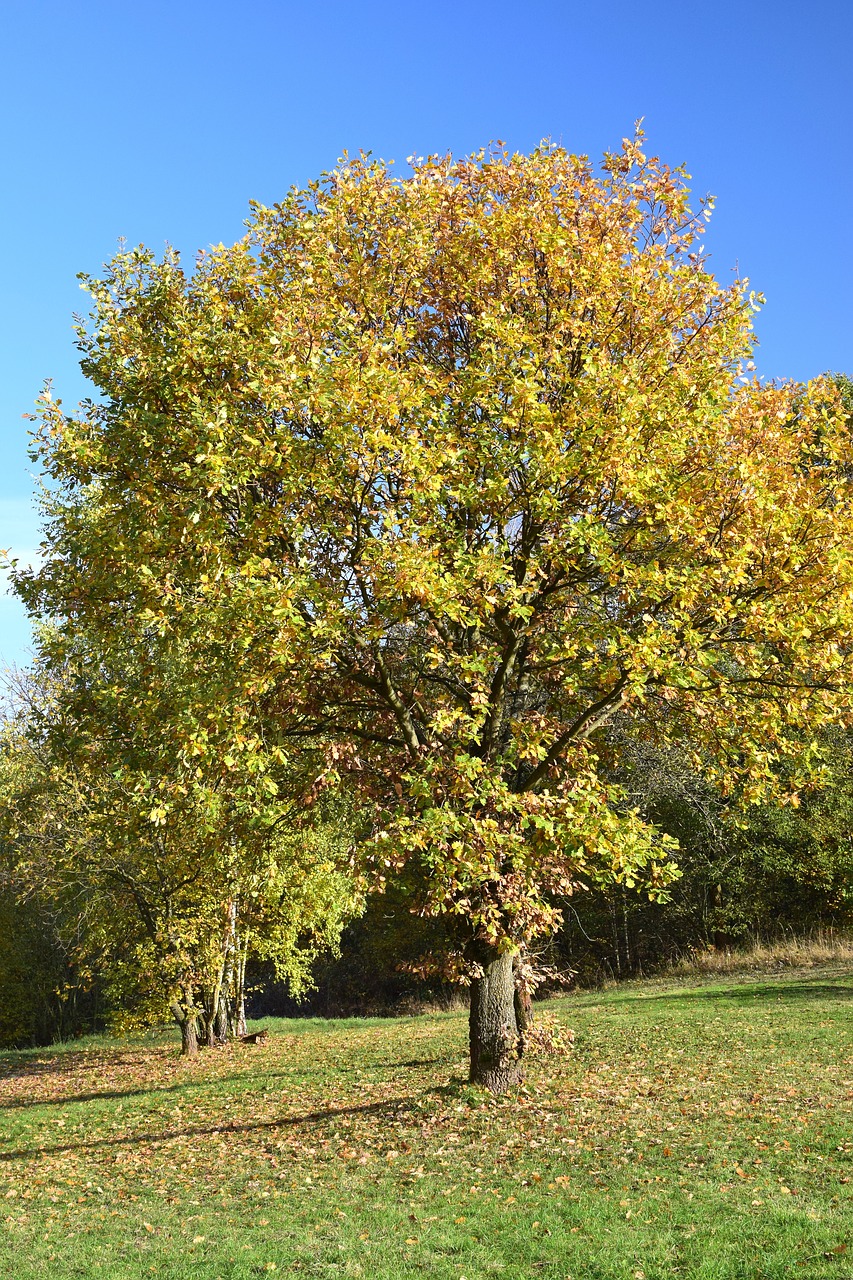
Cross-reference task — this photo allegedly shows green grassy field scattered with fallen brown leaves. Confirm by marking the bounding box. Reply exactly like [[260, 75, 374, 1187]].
[[0, 964, 853, 1280]]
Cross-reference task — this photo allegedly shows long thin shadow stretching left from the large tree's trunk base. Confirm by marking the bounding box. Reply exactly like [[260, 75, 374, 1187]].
[[0, 1076, 466, 1164]]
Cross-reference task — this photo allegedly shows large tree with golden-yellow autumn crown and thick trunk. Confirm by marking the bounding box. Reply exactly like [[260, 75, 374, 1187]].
[[18, 136, 853, 1091]]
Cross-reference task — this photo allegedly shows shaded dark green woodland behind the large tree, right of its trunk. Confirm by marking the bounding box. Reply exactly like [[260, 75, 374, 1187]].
[[556, 726, 853, 975]]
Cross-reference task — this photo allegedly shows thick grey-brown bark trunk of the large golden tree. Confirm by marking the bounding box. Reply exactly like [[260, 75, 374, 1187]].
[[467, 942, 521, 1093]]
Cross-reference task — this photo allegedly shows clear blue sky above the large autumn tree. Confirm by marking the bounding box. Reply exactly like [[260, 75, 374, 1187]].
[[0, 0, 853, 662]]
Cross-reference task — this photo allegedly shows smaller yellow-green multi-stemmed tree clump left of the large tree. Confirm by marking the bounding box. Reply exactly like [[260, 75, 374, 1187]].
[[0, 667, 360, 1056]]
